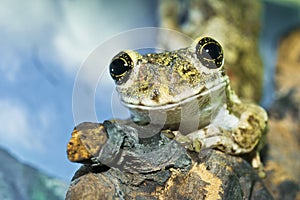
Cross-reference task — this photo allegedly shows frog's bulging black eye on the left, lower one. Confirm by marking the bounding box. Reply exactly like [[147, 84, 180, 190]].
[[109, 51, 133, 84]]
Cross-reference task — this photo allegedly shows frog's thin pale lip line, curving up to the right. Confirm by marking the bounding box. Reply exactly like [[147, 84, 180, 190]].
[[121, 80, 228, 111]]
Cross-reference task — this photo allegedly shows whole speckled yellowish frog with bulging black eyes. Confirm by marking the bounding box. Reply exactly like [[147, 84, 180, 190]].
[[109, 36, 268, 171]]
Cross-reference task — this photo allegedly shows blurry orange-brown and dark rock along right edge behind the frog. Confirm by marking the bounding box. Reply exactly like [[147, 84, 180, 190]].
[[264, 29, 300, 199]]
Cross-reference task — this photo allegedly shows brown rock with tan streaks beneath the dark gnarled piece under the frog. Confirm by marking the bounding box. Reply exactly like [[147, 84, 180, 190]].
[[66, 150, 272, 200]]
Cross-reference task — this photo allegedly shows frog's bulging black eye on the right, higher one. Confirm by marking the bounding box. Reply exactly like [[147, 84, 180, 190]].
[[196, 37, 224, 69]]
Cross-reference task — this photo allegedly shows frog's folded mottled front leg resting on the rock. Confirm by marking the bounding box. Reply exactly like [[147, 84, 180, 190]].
[[175, 104, 267, 168]]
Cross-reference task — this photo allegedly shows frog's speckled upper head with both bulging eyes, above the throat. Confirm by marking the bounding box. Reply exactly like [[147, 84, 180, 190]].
[[110, 37, 229, 128]]
